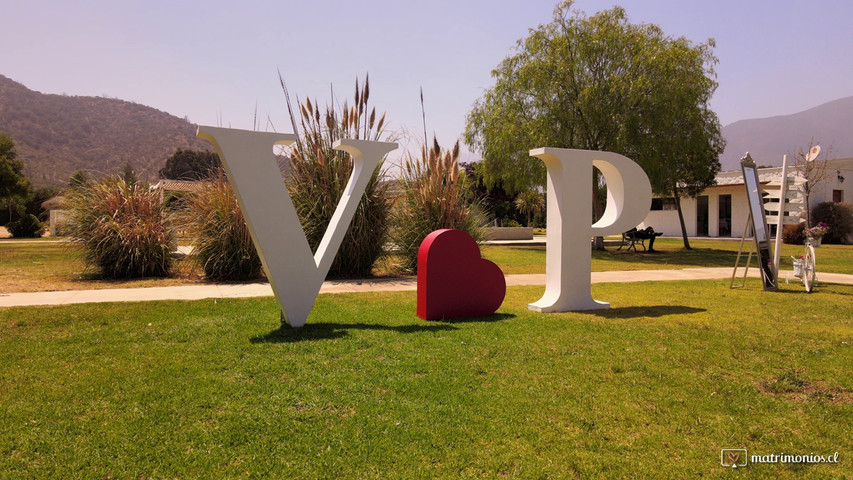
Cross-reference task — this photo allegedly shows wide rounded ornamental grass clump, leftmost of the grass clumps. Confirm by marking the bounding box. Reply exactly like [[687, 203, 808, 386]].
[[67, 177, 177, 278]]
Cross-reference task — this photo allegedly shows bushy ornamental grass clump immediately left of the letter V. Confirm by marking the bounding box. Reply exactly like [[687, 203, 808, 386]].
[[184, 175, 261, 280]]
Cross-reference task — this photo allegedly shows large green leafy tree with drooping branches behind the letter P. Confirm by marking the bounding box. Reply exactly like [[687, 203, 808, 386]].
[[465, 0, 724, 248]]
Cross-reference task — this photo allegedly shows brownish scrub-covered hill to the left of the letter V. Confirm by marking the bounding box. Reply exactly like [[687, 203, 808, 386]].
[[0, 75, 212, 186]]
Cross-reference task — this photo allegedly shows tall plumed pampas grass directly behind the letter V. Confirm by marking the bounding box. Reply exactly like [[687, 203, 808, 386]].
[[282, 74, 391, 277]]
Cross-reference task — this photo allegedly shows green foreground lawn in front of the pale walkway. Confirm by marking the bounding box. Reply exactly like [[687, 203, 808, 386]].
[[0, 280, 853, 479]]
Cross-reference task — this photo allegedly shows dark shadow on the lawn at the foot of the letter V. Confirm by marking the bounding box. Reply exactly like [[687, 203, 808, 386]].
[[249, 323, 457, 343]]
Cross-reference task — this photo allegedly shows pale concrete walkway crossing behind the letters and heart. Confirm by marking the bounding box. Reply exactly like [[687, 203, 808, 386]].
[[0, 268, 853, 307]]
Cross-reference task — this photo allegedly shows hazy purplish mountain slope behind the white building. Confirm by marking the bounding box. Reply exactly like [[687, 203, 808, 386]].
[[720, 97, 853, 170]]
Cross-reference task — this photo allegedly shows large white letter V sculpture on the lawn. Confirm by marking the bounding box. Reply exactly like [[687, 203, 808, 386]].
[[198, 126, 397, 327]]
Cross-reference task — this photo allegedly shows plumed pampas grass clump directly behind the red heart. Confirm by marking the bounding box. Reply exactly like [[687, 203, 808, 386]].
[[391, 139, 484, 272]]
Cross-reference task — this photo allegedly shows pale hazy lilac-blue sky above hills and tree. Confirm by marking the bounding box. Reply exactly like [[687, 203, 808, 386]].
[[0, 0, 853, 162]]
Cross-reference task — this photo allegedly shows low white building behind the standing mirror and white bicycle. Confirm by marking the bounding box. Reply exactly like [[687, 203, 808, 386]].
[[639, 158, 853, 238]]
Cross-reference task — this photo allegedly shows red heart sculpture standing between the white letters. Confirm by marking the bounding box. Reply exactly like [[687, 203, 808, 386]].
[[418, 229, 506, 320]]
